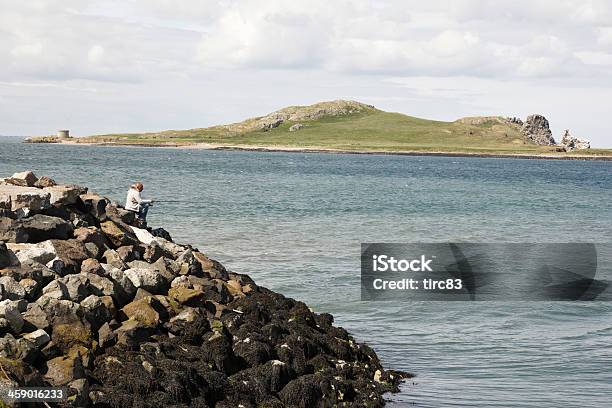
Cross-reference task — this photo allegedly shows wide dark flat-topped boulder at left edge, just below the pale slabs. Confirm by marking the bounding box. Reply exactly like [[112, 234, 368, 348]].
[[0, 214, 73, 243]]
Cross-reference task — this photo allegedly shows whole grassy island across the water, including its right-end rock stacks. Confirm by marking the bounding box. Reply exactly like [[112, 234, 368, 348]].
[[27, 100, 612, 160]]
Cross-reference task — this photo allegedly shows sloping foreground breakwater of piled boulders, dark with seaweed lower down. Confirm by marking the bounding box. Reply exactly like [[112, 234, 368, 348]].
[[0, 172, 408, 408]]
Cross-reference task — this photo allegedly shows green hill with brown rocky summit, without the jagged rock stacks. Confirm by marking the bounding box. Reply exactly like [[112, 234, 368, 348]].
[[78, 101, 601, 154]]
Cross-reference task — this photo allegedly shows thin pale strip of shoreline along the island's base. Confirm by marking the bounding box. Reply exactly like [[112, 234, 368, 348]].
[[45, 141, 612, 161]]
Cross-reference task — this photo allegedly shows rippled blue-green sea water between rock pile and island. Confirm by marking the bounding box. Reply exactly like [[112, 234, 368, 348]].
[[0, 138, 612, 407]]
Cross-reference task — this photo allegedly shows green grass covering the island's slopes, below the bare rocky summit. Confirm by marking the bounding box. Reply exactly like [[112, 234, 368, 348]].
[[83, 109, 612, 155]]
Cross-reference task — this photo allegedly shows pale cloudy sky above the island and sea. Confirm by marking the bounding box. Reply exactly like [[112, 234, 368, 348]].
[[0, 0, 612, 147]]
